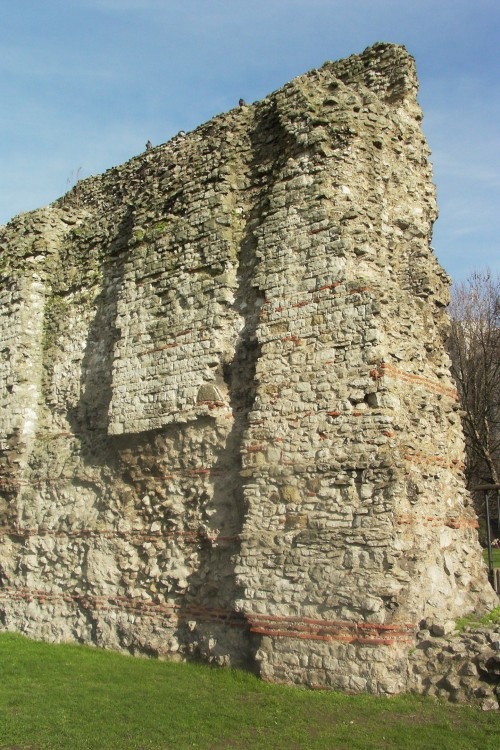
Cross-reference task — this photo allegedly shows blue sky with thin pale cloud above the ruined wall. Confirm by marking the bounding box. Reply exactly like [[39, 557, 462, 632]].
[[0, 0, 500, 281]]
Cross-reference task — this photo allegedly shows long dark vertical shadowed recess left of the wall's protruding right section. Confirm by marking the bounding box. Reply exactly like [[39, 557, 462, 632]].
[[179, 98, 316, 671]]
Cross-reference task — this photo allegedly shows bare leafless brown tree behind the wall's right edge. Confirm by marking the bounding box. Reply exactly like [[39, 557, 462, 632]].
[[449, 271, 500, 489]]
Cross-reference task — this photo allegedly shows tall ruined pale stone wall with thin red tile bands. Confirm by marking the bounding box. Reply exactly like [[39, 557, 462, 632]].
[[0, 44, 498, 704]]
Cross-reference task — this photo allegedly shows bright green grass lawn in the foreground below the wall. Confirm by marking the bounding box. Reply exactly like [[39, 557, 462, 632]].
[[0, 633, 500, 750]]
